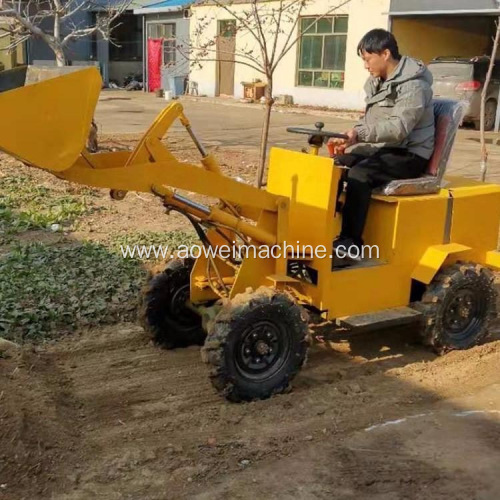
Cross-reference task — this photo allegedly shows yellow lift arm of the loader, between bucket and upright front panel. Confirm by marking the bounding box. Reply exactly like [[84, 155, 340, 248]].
[[65, 103, 279, 245]]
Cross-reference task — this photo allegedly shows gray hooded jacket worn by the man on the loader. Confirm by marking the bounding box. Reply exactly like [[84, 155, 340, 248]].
[[352, 56, 434, 159]]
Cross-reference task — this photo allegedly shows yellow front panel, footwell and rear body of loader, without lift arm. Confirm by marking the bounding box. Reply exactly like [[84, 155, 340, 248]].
[[268, 150, 500, 318]]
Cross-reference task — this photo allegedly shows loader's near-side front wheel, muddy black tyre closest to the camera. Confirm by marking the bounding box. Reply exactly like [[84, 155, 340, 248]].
[[202, 287, 309, 402]]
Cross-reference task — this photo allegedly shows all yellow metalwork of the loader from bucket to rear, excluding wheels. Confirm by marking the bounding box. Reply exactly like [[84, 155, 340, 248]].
[[0, 69, 500, 319]]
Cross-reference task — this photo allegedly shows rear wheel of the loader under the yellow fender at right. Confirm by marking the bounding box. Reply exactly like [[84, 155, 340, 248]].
[[415, 262, 497, 354]]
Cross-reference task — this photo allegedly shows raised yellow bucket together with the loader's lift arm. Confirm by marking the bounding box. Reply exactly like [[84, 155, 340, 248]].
[[0, 68, 288, 296]]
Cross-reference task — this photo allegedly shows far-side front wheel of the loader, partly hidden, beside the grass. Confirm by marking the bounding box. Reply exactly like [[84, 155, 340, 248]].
[[142, 259, 206, 349]]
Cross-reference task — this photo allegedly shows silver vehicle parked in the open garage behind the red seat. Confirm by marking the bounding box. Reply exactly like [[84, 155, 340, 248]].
[[429, 56, 500, 130]]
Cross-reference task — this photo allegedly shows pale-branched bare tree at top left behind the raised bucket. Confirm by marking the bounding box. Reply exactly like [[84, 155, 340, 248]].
[[0, 0, 132, 66]]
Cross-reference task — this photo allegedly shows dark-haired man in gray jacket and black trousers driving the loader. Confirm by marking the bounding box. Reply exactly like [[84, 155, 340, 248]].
[[329, 29, 434, 256]]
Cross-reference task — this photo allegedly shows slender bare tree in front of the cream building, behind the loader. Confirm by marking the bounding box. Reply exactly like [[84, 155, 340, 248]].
[[189, 0, 351, 187]]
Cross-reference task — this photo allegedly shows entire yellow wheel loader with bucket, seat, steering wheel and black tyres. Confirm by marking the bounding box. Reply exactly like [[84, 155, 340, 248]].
[[0, 69, 500, 401]]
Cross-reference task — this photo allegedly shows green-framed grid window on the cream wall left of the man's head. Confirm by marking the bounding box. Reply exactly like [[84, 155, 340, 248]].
[[297, 16, 348, 89]]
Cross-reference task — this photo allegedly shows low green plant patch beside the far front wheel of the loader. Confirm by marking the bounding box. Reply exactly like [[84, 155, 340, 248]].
[[0, 231, 196, 343]]
